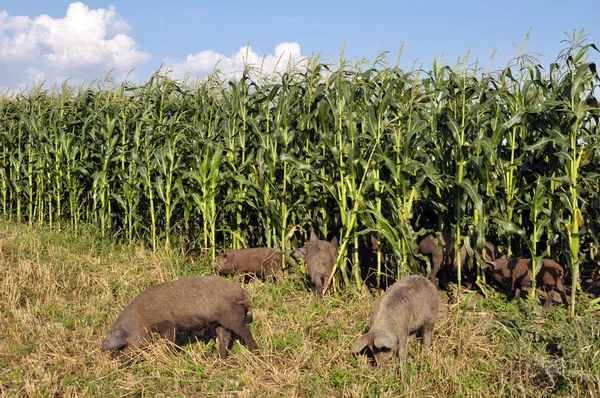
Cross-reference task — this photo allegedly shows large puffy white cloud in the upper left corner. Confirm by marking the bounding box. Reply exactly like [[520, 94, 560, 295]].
[[0, 3, 150, 88]]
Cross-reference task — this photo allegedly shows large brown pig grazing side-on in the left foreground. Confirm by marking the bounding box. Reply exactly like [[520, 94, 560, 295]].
[[102, 276, 258, 358]]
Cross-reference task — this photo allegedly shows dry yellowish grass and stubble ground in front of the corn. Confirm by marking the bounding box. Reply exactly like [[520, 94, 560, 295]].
[[0, 221, 600, 397]]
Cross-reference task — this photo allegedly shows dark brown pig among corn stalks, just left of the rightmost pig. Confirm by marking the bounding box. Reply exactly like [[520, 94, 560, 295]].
[[418, 232, 504, 288]]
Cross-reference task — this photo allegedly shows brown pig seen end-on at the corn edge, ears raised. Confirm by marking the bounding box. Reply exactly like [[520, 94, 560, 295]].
[[291, 229, 338, 301]]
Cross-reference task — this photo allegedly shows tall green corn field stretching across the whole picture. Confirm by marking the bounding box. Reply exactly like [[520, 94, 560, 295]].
[[0, 32, 600, 311]]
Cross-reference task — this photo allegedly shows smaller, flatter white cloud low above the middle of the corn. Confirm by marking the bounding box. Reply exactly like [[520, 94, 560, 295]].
[[164, 43, 306, 78]]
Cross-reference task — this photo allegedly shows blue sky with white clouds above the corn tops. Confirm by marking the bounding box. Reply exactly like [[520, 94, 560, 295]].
[[0, 0, 600, 88]]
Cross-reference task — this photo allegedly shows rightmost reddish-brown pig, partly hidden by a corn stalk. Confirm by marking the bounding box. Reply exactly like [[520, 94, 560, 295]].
[[487, 258, 569, 308]]
